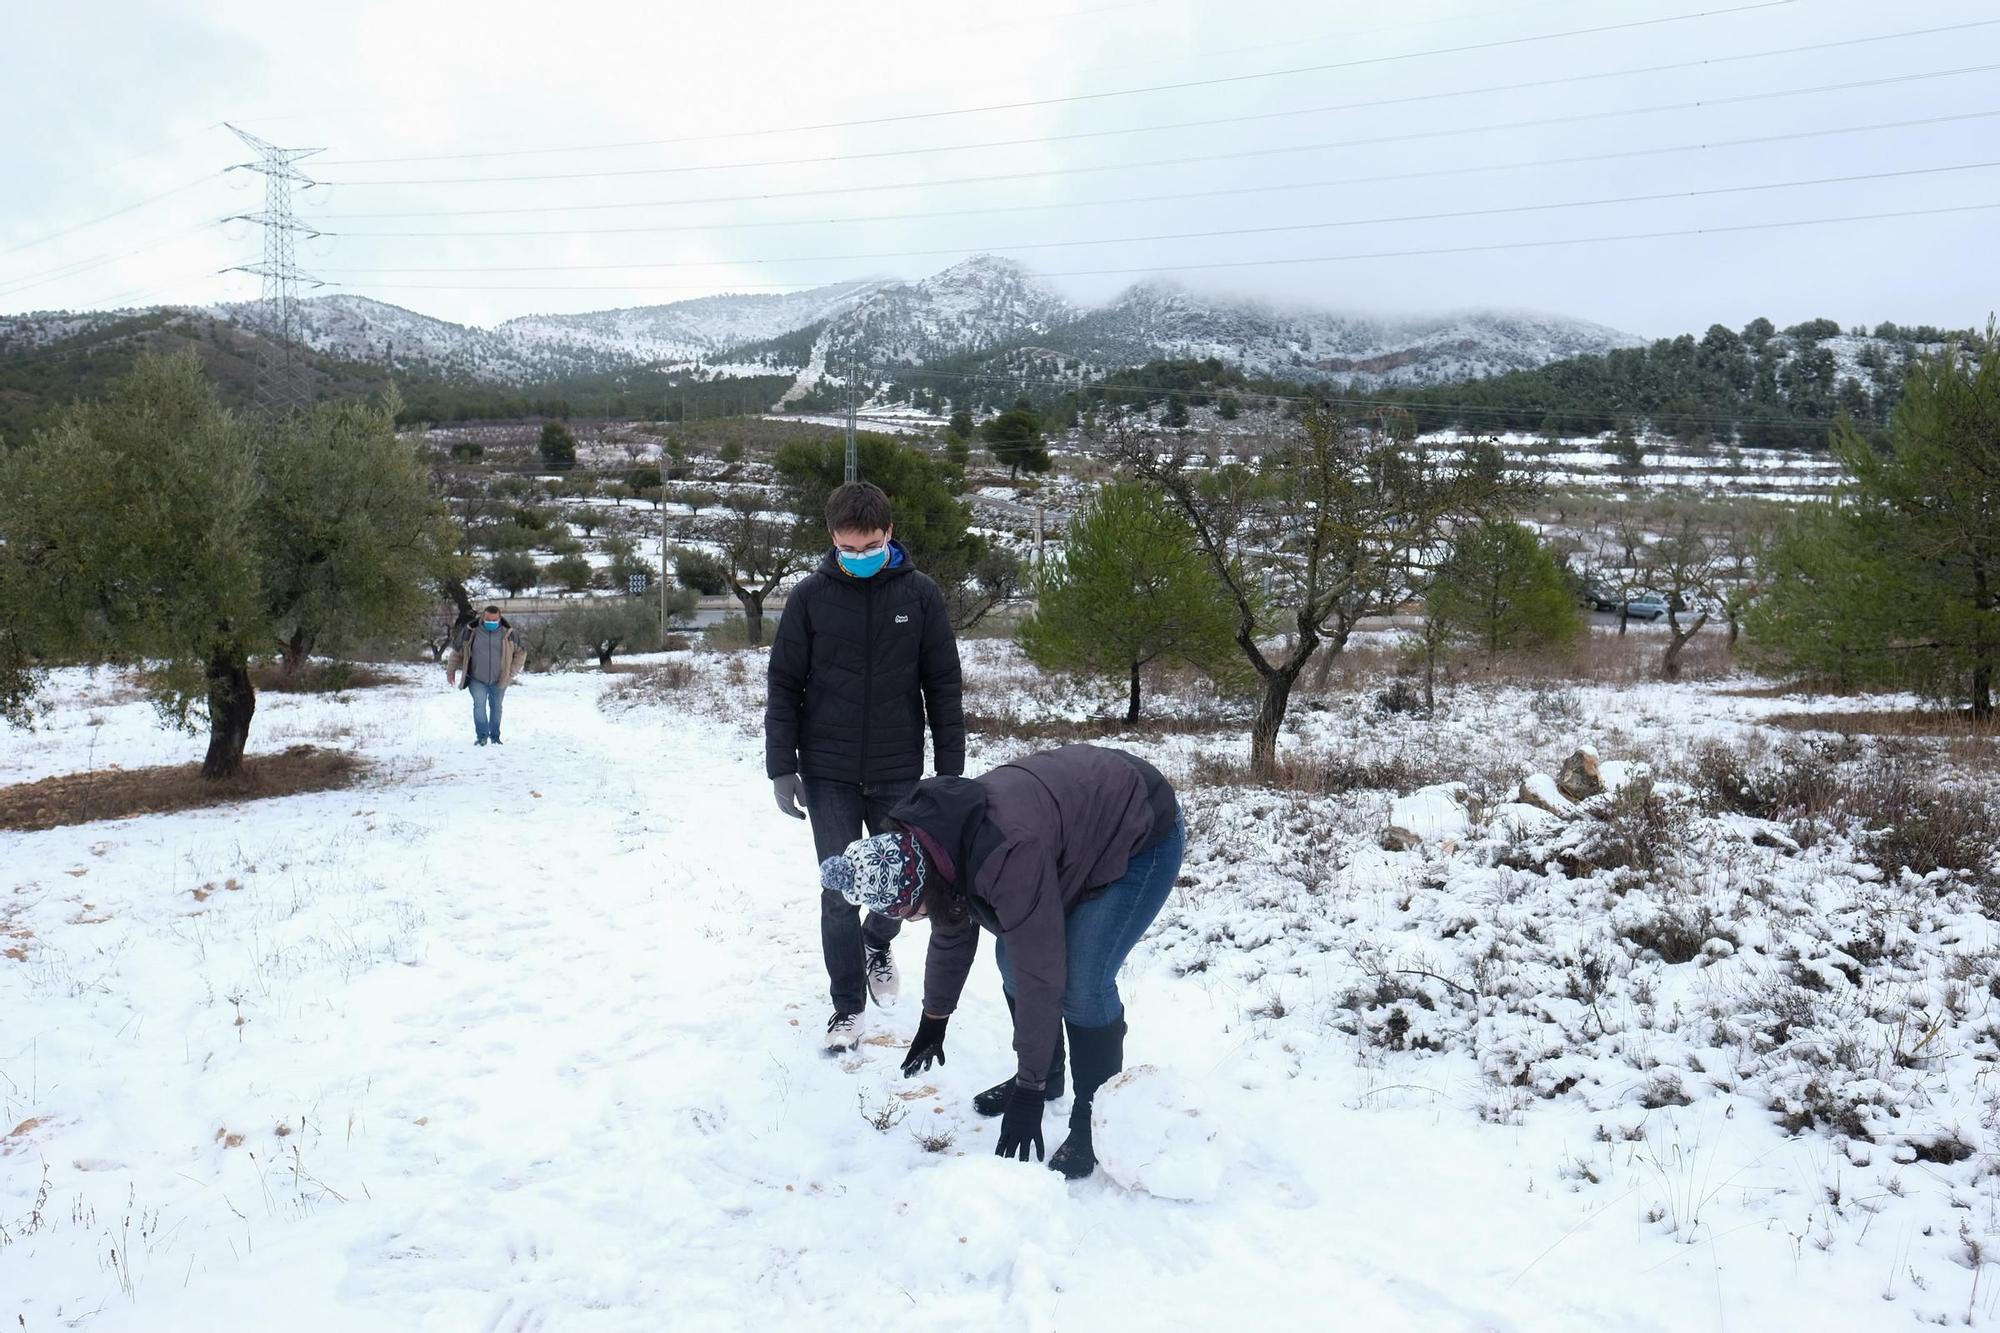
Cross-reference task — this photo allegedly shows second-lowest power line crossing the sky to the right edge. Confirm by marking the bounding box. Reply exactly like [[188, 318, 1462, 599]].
[[308, 160, 2000, 274]]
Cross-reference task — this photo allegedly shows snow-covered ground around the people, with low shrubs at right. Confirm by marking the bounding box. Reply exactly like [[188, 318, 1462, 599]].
[[0, 642, 2000, 1333]]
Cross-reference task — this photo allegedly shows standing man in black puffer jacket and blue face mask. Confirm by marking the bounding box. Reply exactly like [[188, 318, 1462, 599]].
[[764, 482, 966, 1051]]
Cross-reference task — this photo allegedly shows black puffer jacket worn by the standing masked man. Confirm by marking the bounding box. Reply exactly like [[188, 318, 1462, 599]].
[[764, 546, 966, 783]]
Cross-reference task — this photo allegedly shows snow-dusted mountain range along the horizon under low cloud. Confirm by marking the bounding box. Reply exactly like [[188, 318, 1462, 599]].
[[11, 254, 1638, 386]]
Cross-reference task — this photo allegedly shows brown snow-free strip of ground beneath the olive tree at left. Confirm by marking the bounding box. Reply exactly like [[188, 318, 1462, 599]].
[[0, 745, 368, 831]]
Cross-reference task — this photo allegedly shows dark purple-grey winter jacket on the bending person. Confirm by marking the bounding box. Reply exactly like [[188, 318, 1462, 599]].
[[890, 745, 1180, 1085]]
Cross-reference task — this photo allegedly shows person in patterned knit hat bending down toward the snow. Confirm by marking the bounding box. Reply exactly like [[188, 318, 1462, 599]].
[[820, 745, 1188, 1179]]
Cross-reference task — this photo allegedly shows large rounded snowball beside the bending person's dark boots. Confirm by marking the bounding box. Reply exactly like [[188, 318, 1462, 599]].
[[1090, 1065, 1228, 1203]]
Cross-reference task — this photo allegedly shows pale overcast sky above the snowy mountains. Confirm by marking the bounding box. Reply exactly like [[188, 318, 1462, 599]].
[[0, 0, 2000, 336]]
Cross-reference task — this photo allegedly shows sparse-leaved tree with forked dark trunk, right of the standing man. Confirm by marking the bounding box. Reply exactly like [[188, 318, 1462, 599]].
[[1116, 402, 1528, 775]]
